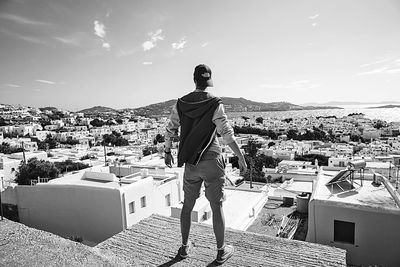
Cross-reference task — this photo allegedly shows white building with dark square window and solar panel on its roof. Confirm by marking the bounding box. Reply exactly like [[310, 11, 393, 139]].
[[306, 171, 400, 267]]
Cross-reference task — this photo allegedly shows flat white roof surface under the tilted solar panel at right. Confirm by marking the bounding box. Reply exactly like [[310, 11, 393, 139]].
[[313, 173, 400, 213]]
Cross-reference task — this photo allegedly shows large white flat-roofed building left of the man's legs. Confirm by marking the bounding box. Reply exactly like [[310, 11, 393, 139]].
[[5, 167, 181, 245]]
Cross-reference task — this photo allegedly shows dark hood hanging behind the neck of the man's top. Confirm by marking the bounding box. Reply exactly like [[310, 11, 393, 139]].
[[177, 97, 221, 119]]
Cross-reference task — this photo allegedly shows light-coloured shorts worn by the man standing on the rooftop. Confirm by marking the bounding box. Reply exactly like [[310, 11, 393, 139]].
[[183, 151, 225, 203]]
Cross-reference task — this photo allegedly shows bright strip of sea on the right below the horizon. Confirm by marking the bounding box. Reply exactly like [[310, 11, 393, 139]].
[[227, 104, 400, 123]]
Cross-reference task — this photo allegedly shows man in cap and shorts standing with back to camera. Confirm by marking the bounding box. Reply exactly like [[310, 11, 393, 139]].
[[165, 64, 247, 264]]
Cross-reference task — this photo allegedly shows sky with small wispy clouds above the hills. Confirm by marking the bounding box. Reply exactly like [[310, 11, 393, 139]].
[[0, 0, 400, 111]]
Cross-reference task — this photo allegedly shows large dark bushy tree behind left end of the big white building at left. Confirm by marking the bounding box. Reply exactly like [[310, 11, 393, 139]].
[[15, 158, 60, 185]]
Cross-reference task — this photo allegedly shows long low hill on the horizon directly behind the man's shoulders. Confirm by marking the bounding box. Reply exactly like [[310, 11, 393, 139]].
[[133, 97, 338, 116]]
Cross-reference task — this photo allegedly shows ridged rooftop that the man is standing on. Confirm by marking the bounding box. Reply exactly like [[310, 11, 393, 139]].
[[96, 215, 346, 266]]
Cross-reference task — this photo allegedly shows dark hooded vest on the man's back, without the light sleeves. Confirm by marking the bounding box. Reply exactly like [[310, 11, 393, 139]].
[[177, 91, 222, 167]]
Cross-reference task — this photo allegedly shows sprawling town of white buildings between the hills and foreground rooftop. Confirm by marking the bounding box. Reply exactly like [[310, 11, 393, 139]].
[[0, 104, 400, 266]]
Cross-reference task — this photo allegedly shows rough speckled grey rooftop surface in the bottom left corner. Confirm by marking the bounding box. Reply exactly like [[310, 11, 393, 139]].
[[0, 220, 126, 266]]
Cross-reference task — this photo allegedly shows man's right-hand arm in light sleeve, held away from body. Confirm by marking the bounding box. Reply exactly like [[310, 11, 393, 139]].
[[213, 104, 247, 174]]
